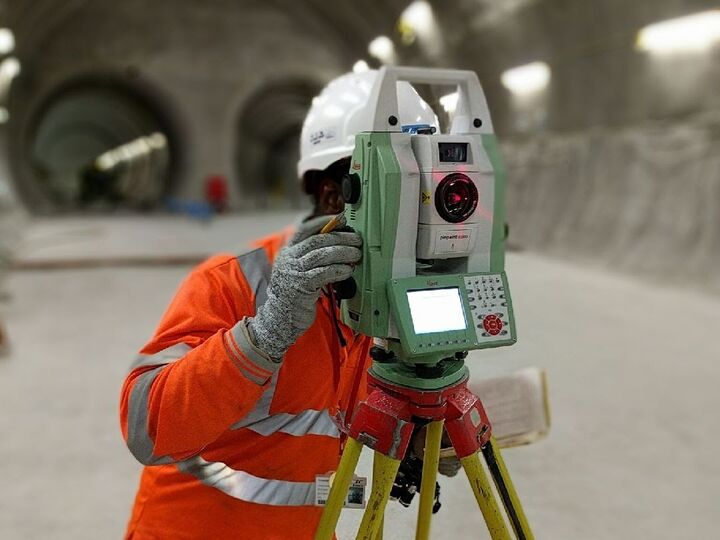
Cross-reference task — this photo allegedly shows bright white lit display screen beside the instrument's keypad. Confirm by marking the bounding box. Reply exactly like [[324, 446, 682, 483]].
[[407, 287, 466, 334]]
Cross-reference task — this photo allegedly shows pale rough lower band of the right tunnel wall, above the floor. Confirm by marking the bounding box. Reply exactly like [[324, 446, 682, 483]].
[[503, 113, 720, 292]]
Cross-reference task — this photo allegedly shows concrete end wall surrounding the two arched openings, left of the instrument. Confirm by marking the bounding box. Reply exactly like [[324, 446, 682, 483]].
[[8, 0, 400, 213]]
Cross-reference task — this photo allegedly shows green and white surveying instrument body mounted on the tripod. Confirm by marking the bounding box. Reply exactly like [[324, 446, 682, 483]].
[[341, 67, 516, 389]]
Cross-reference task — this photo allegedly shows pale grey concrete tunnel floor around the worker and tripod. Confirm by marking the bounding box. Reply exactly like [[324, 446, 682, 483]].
[[0, 217, 720, 540]]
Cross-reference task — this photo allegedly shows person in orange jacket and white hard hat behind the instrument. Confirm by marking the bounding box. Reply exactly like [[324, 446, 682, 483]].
[[120, 71, 457, 540]]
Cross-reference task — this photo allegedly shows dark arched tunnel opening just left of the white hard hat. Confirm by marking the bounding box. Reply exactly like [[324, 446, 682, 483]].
[[235, 80, 320, 208]]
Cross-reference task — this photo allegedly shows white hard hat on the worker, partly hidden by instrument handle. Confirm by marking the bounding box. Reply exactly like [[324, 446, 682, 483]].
[[298, 70, 438, 189]]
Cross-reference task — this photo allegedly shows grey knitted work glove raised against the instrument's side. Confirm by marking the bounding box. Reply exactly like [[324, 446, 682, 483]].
[[248, 216, 362, 362]]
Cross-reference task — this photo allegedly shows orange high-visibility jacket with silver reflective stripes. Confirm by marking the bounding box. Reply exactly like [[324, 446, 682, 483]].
[[120, 233, 370, 540]]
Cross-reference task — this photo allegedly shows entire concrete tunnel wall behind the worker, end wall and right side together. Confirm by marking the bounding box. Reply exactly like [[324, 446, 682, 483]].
[[1, 0, 720, 289]]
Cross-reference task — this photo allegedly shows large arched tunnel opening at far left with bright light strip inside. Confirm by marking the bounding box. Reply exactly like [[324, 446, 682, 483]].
[[28, 82, 174, 213]]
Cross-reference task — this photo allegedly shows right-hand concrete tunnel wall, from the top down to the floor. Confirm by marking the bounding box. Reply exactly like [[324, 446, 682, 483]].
[[444, 0, 720, 292]]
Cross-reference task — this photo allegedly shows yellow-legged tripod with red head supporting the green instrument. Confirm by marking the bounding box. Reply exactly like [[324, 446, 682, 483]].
[[315, 368, 533, 540]]
